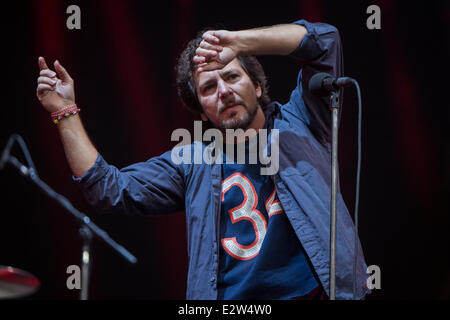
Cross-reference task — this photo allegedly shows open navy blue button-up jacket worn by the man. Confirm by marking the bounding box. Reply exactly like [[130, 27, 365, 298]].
[[73, 20, 369, 299]]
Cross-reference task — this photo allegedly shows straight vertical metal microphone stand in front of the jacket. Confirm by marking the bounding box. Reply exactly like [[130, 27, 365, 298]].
[[330, 91, 339, 300]]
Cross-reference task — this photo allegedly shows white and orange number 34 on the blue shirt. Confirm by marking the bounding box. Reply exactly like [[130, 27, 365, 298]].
[[222, 172, 283, 260]]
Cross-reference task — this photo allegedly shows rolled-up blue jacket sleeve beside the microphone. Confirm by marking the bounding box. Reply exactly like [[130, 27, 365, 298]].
[[287, 20, 344, 143]]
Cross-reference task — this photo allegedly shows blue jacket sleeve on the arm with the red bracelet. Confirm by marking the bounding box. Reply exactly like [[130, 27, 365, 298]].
[[72, 151, 185, 215]]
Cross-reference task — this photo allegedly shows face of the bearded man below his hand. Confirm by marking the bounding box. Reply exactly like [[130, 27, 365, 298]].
[[194, 59, 261, 129]]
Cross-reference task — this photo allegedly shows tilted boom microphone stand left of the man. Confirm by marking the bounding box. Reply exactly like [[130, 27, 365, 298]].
[[1, 155, 137, 300]]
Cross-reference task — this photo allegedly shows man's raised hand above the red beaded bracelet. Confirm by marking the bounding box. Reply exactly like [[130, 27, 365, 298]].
[[36, 57, 75, 112]]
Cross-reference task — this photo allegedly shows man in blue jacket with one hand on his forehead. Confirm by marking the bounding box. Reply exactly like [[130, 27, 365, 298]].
[[37, 20, 369, 299]]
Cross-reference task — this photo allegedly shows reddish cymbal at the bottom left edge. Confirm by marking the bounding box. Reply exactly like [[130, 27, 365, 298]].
[[0, 266, 41, 299]]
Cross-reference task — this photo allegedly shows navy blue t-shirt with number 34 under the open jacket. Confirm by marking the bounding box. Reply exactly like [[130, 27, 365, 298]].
[[218, 138, 319, 299]]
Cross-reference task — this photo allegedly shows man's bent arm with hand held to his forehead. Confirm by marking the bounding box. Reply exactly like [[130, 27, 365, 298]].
[[193, 20, 344, 143]]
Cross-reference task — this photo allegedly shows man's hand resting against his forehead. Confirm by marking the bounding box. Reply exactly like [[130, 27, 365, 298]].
[[193, 30, 239, 72]]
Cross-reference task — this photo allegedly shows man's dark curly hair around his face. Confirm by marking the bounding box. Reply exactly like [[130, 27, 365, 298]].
[[175, 29, 270, 116]]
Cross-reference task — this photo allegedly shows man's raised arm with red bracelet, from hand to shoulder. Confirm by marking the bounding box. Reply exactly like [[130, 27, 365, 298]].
[[37, 57, 184, 214]]
